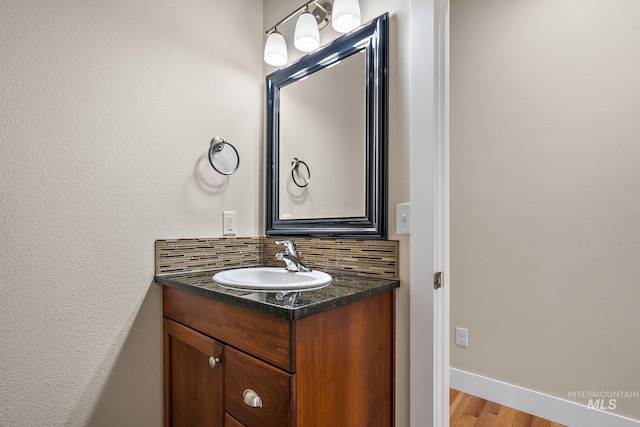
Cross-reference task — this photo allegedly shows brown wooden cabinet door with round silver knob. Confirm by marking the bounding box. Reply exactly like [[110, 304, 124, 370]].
[[164, 318, 224, 427]]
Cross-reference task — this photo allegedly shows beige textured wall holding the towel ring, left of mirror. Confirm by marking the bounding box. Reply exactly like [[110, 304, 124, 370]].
[[0, 0, 263, 426]]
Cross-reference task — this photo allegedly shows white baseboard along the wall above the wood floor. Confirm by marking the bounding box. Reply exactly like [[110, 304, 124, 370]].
[[449, 368, 640, 427]]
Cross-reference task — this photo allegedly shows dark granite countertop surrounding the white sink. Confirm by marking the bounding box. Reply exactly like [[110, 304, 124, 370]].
[[155, 270, 400, 320]]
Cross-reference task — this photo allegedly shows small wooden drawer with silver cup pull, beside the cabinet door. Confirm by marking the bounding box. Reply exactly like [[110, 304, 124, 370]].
[[224, 347, 295, 427]]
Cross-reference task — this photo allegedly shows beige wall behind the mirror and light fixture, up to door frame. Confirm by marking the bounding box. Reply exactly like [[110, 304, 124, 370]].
[[263, 0, 410, 426]]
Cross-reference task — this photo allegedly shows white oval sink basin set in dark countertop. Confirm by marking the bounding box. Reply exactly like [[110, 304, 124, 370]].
[[213, 267, 333, 292]]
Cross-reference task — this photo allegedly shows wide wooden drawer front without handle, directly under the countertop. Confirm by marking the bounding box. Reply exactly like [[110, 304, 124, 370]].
[[163, 286, 295, 372]]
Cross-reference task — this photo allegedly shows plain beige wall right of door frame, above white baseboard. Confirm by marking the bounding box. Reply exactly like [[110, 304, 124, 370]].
[[451, 0, 640, 419]]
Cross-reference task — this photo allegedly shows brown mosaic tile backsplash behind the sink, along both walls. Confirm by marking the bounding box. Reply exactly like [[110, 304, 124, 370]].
[[156, 237, 398, 279]]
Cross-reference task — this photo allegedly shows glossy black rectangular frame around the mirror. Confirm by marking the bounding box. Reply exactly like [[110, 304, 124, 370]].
[[265, 13, 389, 239]]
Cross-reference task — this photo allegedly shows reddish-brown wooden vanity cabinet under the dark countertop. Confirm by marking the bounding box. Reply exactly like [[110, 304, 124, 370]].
[[163, 286, 395, 427]]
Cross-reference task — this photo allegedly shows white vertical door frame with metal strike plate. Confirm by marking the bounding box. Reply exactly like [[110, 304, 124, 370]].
[[409, 0, 450, 427]]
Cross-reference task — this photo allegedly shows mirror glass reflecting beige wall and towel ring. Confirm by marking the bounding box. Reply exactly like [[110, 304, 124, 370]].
[[279, 51, 367, 219]]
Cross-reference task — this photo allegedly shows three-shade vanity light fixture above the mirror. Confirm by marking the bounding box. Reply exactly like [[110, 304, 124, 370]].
[[264, 0, 360, 67]]
